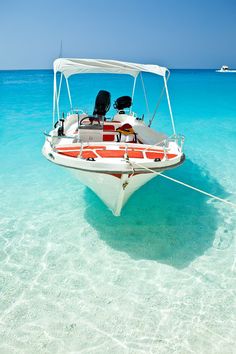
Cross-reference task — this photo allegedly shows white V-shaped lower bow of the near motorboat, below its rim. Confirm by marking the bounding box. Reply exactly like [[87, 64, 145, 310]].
[[71, 170, 159, 216]]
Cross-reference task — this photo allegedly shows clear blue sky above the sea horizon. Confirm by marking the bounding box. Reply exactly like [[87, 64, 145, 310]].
[[0, 0, 236, 69]]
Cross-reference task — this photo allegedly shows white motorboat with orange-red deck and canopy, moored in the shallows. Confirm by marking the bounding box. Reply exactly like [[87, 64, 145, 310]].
[[42, 58, 185, 216]]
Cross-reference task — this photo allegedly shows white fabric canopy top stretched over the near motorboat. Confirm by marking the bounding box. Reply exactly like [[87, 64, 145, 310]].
[[53, 58, 169, 78]]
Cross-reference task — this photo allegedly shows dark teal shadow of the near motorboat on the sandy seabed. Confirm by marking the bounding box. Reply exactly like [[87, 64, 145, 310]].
[[85, 160, 226, 269]]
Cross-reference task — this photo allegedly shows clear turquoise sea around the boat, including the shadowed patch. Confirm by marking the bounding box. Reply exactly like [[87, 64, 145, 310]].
[[0, 71, 236, 354]]
